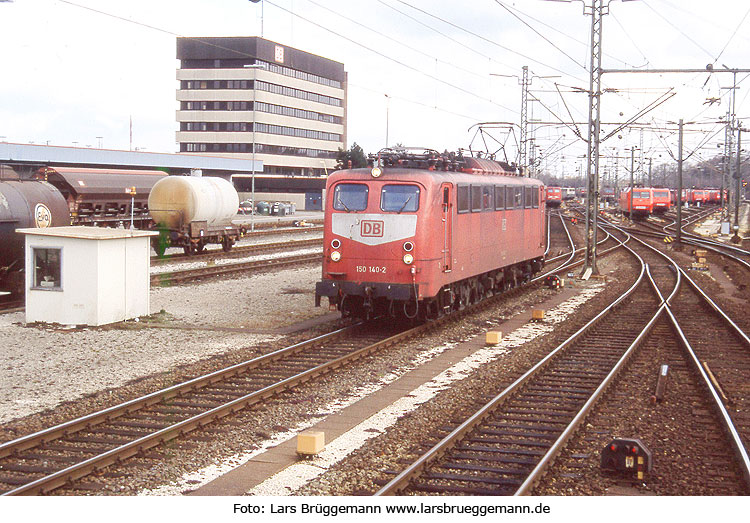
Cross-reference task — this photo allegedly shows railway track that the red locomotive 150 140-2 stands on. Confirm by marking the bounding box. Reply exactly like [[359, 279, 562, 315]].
[[0, 213, 584, 495]]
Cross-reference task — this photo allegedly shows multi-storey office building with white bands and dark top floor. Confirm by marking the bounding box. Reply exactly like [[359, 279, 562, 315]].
[[177, 37, 347, 177]]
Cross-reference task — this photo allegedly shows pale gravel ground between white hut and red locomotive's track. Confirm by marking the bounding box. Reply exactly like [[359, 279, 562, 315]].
[[0, 267, 328, 423]]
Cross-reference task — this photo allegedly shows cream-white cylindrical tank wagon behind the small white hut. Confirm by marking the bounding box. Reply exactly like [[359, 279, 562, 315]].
[[148, 176, 240, 256]]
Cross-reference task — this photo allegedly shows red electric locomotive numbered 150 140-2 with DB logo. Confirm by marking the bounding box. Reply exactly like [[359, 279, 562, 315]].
[[315, 149, 546, 320]]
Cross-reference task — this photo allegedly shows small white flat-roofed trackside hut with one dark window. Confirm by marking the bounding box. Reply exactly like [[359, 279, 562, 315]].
[[17, 227, 157, 326]]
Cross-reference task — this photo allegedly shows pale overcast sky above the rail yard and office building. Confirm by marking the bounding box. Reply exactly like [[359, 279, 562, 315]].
[[0, 0, 750, 179]]
